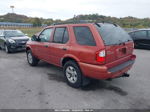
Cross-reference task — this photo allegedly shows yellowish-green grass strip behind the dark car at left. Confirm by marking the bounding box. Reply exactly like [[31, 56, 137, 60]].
[[0, 27, 42, 37]]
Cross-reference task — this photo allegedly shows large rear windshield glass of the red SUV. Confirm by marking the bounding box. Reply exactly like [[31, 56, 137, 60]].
[[95, 23, 132, 45]]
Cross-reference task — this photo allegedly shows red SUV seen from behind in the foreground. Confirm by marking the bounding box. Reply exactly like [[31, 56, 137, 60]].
[[26, 23, 136, 88]]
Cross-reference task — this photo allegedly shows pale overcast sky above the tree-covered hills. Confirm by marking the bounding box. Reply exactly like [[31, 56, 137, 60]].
[[0, 0, 150, 20]]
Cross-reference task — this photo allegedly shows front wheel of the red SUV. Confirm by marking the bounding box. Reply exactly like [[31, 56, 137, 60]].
[[27, 50, 39, 66]]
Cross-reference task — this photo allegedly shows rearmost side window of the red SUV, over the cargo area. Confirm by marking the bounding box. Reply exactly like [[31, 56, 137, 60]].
[[74, 26, 96, 46]]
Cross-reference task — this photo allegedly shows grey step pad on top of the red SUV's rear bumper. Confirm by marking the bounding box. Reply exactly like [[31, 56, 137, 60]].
[[108, 60, 135, 73]]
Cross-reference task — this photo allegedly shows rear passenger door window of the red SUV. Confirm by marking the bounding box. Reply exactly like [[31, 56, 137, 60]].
[[53, 27, 69, 43]]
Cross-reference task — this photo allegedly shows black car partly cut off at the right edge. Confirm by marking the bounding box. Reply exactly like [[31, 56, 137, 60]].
[[129, 29, 150, 49]]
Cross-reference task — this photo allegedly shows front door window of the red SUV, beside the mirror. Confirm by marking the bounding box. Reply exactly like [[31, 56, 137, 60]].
[[39, 28, 53, 42]]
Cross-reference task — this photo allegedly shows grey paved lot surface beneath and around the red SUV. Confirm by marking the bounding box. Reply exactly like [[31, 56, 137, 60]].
[[0, 50, 150, 109]]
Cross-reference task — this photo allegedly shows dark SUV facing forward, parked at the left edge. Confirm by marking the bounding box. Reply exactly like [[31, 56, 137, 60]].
[[0, 30, 29, 53]]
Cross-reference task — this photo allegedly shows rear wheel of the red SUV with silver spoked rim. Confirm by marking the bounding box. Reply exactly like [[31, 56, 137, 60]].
[[63, 61, 82, 88]]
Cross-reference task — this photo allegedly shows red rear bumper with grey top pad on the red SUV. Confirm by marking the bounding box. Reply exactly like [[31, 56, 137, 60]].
[[79, 55, 135, 79]]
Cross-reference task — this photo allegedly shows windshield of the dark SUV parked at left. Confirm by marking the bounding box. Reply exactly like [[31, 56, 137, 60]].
[[4, 30, 25, 37]]
